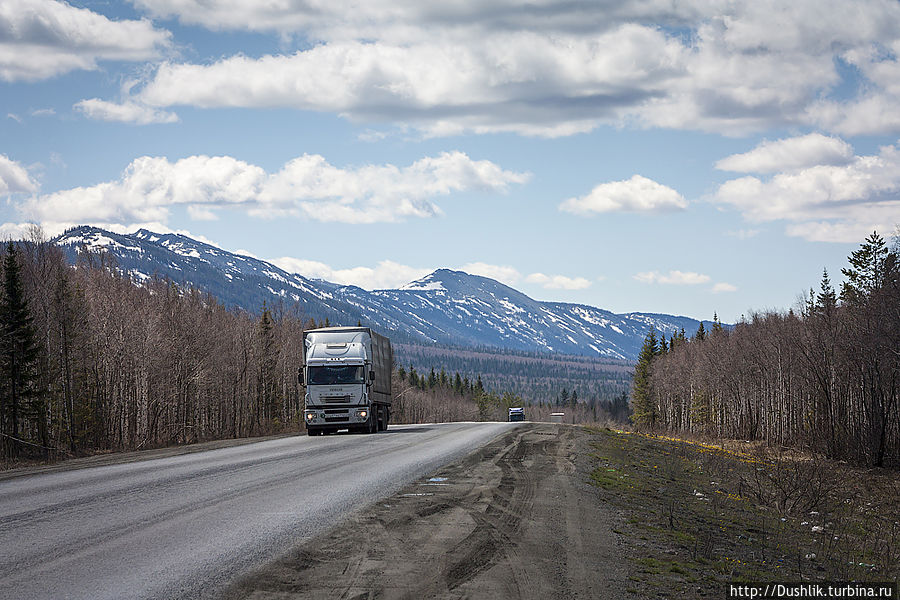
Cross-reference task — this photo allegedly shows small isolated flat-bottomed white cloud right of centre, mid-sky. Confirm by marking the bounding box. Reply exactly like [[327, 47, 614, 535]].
[[559, 175, 687, 215]]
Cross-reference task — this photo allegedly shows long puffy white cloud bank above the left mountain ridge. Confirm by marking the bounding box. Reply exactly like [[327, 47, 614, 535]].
[[19, 152, 529, 230]]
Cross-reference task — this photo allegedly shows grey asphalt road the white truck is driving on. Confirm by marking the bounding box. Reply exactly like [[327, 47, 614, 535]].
[[0, 423, 517, 600]]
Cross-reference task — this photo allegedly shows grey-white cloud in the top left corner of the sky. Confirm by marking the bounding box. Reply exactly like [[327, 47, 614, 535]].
[[0, 0, 171, 81]]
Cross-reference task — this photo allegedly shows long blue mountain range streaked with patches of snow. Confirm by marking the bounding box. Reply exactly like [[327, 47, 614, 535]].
[[54, 227, 711, 359]]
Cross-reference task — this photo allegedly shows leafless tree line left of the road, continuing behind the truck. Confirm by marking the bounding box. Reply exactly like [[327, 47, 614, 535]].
[[0, 229, 536, 464]]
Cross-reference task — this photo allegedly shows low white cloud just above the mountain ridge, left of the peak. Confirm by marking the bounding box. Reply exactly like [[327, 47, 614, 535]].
[[270, 256, 434, 290]]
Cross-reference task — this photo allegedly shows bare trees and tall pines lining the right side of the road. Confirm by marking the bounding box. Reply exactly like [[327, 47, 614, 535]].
[[631, 233, 900, 467]]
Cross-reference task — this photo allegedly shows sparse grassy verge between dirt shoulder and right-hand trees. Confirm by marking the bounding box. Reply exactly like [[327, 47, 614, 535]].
[[589, 428, 900, 598]]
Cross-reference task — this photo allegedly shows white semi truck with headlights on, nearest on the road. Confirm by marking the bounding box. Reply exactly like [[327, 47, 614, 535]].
[[299, 327, 394, 435]]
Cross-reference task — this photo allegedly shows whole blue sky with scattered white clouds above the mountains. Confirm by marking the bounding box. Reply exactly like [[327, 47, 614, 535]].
[[0, 0, 900, 322]]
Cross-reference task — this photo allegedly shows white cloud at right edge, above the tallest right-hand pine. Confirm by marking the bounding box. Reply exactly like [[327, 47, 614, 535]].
[[713, 141, 900, 242]]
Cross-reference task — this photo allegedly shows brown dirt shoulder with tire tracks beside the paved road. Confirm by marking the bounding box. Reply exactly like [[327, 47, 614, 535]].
[[225, 424, 628, 600]]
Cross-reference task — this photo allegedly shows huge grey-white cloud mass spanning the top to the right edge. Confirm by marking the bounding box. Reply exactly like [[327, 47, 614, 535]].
[[93, 0, 900, 136]]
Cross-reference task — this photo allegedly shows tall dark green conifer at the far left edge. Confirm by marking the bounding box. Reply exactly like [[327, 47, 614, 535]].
[[0, 242, 44, 456]]
